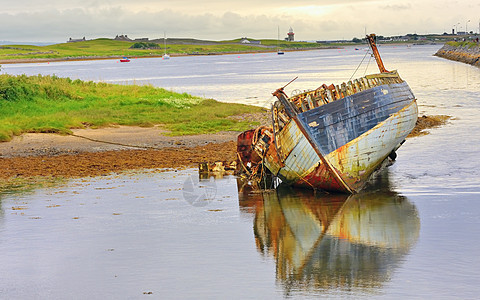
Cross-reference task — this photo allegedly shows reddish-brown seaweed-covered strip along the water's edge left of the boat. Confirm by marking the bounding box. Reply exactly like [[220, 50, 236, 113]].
[[0, 141, 236, 180]]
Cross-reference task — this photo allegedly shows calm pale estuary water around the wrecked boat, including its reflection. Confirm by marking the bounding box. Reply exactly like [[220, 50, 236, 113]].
[[0, 45, 480, 299]]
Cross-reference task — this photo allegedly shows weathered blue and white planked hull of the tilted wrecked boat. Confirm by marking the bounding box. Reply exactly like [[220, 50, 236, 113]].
[[264, 77, 418, 193]]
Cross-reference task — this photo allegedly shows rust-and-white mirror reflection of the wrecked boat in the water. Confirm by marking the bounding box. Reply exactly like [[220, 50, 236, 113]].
[[239, 173, 420, 295]]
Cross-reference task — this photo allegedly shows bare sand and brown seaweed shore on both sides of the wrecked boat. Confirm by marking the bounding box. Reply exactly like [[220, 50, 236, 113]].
[[0, 116, 449, 180]]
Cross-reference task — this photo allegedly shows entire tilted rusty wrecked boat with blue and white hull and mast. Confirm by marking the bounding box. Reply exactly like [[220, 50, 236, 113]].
[[237, 34, 418, 193]]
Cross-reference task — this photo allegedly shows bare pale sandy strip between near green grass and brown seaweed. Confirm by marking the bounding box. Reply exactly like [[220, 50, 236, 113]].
[[0, 126, 238, 158]]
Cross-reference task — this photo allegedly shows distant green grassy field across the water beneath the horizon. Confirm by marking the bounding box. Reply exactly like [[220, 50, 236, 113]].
[[0, 39, 330, 61]]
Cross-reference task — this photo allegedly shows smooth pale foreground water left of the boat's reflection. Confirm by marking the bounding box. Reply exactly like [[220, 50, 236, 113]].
[[0, 170, 281, 299]]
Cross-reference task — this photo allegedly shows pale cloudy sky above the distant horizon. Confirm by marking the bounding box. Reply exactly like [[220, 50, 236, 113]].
[[0, 0, 480, 42]]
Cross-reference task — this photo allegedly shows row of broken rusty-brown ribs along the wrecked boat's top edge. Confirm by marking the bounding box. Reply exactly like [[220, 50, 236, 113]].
[[289, 71, 403, 112]]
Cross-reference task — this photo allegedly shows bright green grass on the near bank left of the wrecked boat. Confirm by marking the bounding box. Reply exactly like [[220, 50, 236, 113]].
[[0, 75, 261, 141]]
